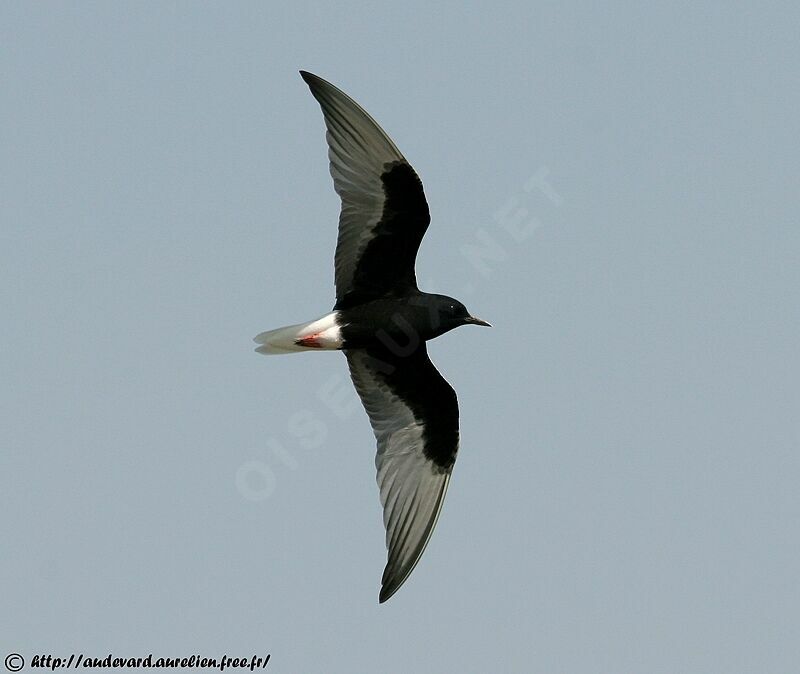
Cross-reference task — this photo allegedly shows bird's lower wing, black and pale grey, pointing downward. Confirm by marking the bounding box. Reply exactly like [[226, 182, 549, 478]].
[[345, 342, 458, 602]]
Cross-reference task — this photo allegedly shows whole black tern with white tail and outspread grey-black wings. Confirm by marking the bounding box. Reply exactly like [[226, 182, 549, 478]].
[[255, 70, 491, 603]]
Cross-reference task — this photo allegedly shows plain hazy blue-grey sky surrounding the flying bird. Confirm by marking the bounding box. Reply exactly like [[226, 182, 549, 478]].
[[0, 2, 800, 674]]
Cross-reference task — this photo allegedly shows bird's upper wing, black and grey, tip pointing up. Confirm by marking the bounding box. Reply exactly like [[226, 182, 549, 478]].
[[300, 71, 430, 309]]
